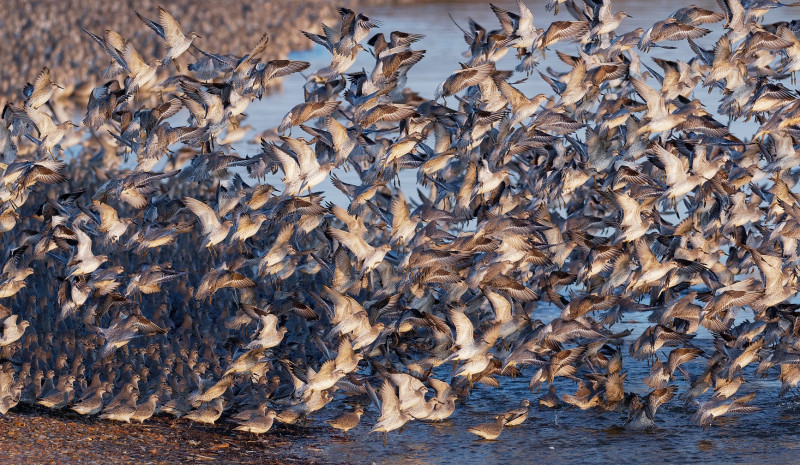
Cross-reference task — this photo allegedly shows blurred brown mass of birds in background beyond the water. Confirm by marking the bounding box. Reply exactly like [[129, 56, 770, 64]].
[[0, 0, 406, 101]]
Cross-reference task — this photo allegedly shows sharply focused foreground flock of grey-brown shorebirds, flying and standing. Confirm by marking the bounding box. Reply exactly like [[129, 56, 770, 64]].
[[0, 0, 800, 441]]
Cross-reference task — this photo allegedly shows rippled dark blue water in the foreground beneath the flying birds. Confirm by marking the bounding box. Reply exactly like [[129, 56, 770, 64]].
[[300, 300, 800, 464]]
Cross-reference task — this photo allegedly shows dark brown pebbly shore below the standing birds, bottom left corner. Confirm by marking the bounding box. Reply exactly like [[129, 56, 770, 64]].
[[0, 405, 339, 465]]
